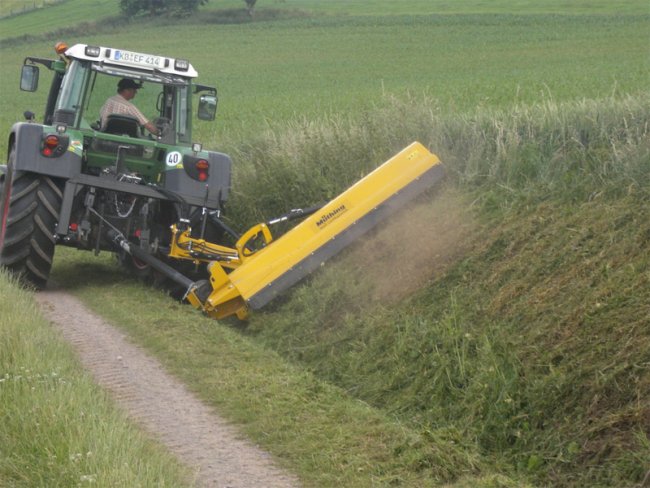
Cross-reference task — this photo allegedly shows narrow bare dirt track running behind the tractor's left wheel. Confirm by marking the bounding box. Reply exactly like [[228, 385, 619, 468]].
[[36, 288, 298, 488]]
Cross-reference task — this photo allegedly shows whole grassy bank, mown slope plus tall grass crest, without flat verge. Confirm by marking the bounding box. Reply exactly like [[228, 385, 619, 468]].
[[233, 94, 650, 486]]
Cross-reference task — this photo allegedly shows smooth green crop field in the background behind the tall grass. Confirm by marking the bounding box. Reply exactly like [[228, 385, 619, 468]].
[[0, 0, 650, 155]]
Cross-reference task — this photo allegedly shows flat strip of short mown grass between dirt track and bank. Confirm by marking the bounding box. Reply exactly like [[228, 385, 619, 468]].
[[49, 249, 521, 487]]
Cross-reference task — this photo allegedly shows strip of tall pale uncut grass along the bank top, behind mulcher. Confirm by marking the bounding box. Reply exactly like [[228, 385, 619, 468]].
[[221, 93, 650, 223]]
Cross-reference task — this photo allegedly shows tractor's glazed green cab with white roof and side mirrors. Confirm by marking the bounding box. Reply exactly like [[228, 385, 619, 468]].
[[21, 44, 217, 177]]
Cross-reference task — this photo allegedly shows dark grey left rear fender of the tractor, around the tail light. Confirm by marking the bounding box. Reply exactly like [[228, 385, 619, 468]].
[[9, 122, 81, 178]]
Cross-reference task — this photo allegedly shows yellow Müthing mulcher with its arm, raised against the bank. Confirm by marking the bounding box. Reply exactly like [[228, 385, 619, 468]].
[[114, 142, 443, 319]]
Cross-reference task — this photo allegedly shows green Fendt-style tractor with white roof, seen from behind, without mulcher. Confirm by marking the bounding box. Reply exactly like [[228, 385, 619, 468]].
[[0, 43, 232, 288]]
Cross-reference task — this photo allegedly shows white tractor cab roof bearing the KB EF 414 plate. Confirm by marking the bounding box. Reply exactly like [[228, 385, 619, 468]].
[[65, 44, 198, 78]]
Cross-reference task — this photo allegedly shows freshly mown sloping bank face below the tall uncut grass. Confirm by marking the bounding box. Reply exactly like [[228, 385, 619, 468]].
[[249, 193, 650, 486]]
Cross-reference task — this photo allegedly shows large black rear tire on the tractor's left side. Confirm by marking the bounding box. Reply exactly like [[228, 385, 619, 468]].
[[0, 151, 63, 289]]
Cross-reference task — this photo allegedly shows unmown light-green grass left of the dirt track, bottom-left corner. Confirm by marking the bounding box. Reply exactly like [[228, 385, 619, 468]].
[[0, 270, 189, 487]]
